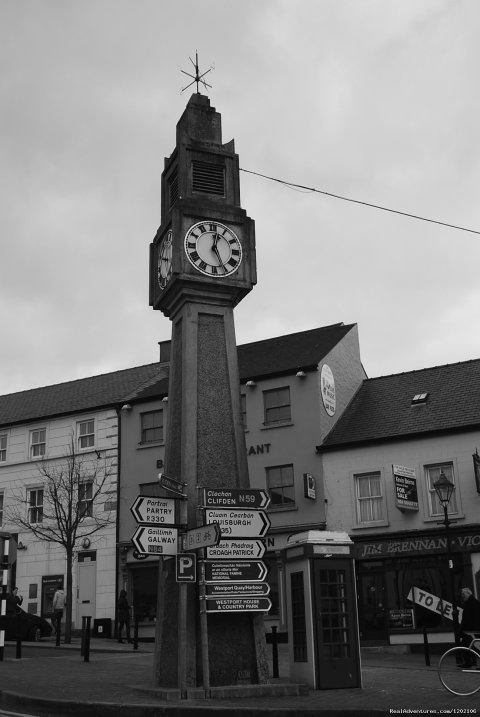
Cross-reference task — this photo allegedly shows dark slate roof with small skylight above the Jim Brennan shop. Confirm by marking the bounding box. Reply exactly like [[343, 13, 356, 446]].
[[318, 359, 480, 451]]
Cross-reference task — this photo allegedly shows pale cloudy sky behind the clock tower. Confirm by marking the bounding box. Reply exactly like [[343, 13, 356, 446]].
[[0, 0, 480, 394]]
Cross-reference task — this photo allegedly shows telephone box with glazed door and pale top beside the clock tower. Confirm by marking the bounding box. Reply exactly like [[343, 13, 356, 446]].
[[282, 530, 362, 690]]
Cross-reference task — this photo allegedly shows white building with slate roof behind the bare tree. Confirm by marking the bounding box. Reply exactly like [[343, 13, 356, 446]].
[[0, 364, 158, 628]]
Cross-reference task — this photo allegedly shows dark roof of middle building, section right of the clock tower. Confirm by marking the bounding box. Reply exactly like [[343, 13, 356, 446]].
[[238, 324, 355, 381]]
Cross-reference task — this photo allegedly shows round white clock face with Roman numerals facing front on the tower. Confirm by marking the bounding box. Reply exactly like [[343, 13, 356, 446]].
[[185, 221, 242, 279]]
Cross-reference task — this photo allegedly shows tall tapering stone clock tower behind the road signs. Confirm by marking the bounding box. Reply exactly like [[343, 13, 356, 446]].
[[150, 93, 268, 688]]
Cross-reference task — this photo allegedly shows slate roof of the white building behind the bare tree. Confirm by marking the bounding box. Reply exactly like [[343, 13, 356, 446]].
[[0, 363, 160, 426]]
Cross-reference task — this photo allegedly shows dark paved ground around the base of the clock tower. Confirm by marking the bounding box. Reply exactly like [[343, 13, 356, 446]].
[[0, 640, 480, 717]]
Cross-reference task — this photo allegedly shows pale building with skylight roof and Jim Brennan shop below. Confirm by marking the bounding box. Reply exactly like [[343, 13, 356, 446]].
[[317, 361, 480, 643]]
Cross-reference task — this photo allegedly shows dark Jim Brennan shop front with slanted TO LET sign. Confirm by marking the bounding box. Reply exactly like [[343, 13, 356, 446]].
[[353, 526, 480, 645]]
